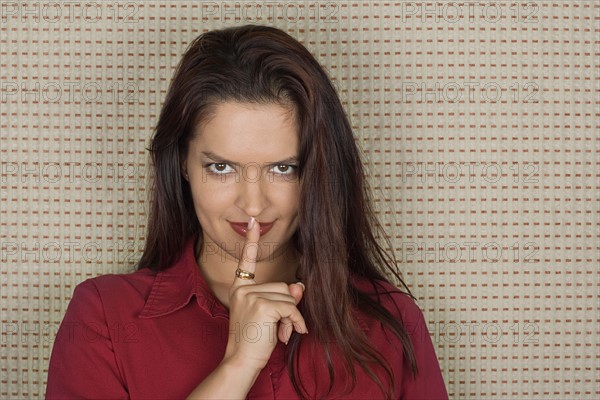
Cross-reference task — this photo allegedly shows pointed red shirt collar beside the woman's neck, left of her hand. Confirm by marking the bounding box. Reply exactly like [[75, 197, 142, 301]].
[[139, 238, 228, 318]]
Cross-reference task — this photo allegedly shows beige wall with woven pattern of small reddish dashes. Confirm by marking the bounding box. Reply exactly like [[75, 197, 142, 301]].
[[0, 0, 600, 399]]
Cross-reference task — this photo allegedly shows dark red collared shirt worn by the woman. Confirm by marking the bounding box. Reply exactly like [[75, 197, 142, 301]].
[[46, 241, 448, 399]]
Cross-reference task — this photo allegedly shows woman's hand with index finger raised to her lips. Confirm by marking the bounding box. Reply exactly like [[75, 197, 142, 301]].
[[224, 218, 308, 370]]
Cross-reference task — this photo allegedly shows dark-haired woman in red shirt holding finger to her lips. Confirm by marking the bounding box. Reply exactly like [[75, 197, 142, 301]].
[[46, 26, 447, 399]]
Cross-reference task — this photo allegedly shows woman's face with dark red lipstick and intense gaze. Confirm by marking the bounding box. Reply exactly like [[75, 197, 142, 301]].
[[183, 101, 300, 261]]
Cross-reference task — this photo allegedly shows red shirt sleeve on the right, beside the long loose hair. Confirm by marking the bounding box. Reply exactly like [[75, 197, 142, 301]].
[[401, 299, 448, 400]]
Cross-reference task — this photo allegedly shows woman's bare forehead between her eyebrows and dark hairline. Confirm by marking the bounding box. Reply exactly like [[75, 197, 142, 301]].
[[190, 102, 299, 162]]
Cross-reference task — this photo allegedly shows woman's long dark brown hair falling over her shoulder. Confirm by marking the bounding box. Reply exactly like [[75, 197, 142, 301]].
[[138, 25, 417, 396]]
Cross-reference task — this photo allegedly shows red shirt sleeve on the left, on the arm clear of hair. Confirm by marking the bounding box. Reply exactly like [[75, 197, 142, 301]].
[[46, 280, 129, 399]]
